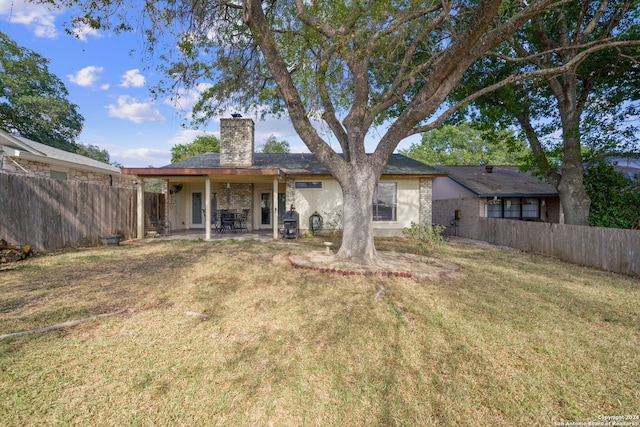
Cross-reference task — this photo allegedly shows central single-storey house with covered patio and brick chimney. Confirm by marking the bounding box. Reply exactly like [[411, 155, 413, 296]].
[[123, 118, 444, 238]]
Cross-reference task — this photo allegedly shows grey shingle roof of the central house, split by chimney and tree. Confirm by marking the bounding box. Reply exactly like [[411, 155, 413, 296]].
[[161, 153, 443, 175]]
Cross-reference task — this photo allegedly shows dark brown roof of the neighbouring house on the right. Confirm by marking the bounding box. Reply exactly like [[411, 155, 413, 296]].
[[437, 166, 558, 197]]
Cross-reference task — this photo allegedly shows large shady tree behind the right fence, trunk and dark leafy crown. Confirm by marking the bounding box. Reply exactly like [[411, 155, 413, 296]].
[[458, 0, 640, 225]]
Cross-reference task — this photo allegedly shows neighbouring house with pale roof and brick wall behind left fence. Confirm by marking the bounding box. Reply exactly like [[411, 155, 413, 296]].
[[0, 130, 135, 189]]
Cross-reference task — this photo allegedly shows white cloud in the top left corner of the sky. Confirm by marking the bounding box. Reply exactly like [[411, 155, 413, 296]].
[[0, 0, 62, 38]]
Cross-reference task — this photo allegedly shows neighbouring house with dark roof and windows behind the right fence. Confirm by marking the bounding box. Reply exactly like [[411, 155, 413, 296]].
[[433, 166, 563, 238]]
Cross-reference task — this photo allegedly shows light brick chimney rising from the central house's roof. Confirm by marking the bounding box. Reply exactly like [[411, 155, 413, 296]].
[[220, 117, 254, 166]]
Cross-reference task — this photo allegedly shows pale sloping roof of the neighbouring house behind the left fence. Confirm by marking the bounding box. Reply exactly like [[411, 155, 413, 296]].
[[0, 129, 120, 174]]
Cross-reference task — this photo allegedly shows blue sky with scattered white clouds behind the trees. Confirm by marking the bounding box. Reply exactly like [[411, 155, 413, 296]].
[[0, 0, 419, 167]]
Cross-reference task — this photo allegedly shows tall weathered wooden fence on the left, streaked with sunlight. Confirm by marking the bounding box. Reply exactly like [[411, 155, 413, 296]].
[[0, 174, 162, 251]]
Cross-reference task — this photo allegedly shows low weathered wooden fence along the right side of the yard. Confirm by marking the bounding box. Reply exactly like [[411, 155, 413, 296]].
[[478, 218, 640, 276]]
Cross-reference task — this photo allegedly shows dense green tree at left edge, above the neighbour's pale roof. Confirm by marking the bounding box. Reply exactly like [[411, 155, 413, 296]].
[[0, 32, 84, 153]]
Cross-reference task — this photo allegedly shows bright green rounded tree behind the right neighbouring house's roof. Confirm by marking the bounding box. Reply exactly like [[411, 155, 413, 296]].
[[400, 123, 528, 166]]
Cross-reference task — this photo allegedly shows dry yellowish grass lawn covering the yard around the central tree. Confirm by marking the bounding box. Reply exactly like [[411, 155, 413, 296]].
[[0, 239, 640, 426]]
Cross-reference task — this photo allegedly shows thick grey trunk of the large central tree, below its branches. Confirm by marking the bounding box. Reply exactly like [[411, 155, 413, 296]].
[[336, 169, 377, 265]]
